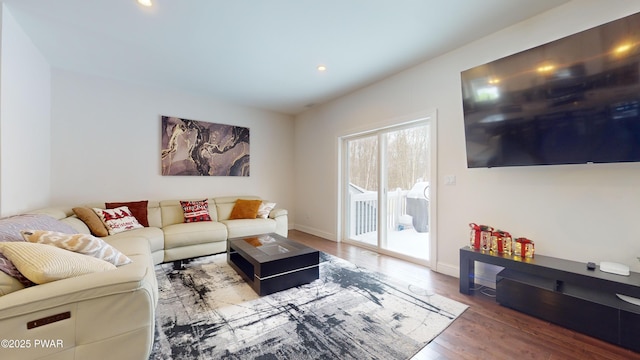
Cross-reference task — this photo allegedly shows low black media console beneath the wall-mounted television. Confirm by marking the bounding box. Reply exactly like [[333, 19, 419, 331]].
[[460, 246, 640, 352]]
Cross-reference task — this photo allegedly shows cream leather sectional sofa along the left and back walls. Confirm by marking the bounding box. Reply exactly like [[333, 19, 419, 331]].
[[0, 196, 288, 359]]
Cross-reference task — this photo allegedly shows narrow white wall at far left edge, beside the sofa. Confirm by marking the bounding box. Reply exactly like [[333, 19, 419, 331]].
[[0, 4, 51, 216]]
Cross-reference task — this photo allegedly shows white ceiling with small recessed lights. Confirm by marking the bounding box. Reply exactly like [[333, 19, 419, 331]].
[[0, 0, 568, 114]]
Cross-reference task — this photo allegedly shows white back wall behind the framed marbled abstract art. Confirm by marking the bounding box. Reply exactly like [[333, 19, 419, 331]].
[[51, 69, 293, 222]]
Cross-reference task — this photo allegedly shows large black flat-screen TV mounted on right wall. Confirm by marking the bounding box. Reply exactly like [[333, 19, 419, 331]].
[[461, 13, 640, 168]]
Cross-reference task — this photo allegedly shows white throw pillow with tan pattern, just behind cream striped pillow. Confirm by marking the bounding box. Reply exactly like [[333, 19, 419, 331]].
[[21, 230, 131, 266]]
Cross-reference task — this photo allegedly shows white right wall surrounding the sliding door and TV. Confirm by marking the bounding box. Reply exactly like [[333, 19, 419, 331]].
[[295, 0, 640, 276]]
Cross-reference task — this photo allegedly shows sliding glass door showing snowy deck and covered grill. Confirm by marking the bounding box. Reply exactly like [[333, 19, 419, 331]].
[[343, 121, 430, 262]]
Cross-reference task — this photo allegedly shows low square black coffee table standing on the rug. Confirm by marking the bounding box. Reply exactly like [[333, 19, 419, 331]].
[[227, 234, 320, 296]]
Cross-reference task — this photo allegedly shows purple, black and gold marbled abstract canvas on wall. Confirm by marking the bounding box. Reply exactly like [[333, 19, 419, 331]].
[[161, 116, 249, 176]]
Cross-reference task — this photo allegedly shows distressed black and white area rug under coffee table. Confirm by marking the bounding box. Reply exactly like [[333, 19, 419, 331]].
[[150, 253, 467, 360]]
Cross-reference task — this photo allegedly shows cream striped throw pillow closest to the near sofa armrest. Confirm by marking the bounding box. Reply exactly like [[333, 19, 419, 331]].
[[0, 241, 116, 284]]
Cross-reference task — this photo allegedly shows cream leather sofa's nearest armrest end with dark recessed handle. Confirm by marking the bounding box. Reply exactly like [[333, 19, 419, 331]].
[[0, 255, 157, 359]]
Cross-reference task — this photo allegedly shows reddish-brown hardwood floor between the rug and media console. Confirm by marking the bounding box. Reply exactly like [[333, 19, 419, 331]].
[[289, 230, 640, 360]]
